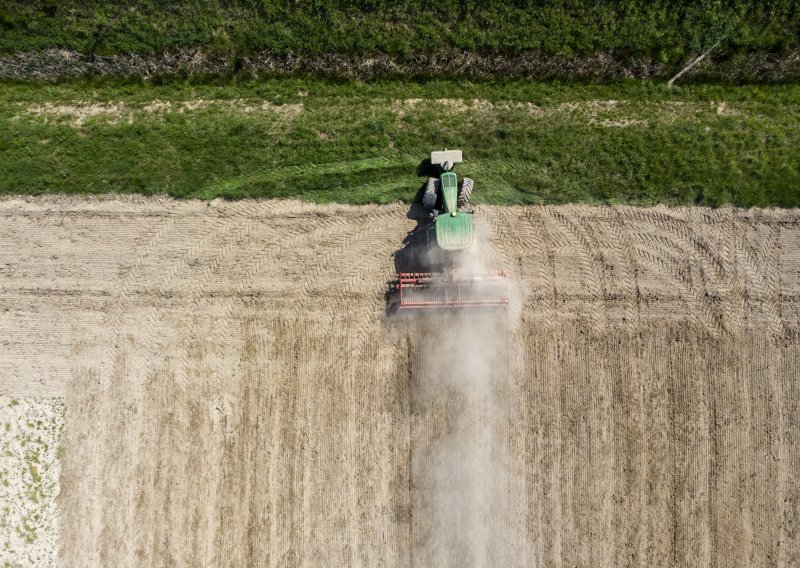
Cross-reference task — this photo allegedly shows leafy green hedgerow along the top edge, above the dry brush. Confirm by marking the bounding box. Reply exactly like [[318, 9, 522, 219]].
[[0, 0, 800, 61]]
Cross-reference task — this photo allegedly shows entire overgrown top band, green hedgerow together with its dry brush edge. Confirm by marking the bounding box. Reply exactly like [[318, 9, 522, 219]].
[[0, 0, 800, 81]]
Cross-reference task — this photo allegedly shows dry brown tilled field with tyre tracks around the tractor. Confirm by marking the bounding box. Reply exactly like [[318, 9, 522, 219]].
[[0, 198, 800, 567]]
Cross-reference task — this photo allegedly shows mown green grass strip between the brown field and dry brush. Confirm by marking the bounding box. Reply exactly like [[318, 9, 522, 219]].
[[0, 79, 800, 207]]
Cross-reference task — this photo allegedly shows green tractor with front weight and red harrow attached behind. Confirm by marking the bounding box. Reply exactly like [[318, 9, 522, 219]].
[[397, 149, 508, 309]]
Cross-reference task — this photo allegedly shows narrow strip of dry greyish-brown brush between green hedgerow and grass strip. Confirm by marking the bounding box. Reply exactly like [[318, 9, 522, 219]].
[[0, 48, 800, 84]]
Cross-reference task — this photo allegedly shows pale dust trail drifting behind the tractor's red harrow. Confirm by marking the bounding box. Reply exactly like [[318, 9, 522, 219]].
[[412, 241, 528, 566]]
